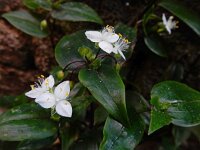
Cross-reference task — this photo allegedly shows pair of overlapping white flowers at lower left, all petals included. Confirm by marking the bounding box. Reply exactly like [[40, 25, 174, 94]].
[[25, 75, 72, 117]]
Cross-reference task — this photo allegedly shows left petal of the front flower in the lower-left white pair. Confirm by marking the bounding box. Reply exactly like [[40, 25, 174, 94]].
[[35, 93, 56, 108]]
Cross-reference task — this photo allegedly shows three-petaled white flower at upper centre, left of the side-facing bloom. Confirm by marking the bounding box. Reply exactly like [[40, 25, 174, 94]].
[[85, 26, 119, 54]]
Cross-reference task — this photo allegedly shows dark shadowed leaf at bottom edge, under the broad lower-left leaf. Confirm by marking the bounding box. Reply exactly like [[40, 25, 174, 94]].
[[17, 137, 55, 150]]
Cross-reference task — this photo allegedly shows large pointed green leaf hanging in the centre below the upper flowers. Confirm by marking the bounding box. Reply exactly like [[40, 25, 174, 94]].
[[79, 66, 128, 124]]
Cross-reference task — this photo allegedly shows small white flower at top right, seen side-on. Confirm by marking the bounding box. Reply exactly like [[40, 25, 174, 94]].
[[162, 13, 178, 34]]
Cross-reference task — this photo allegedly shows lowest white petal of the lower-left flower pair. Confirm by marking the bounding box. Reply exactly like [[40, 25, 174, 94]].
[[56, 100, 72, 117]]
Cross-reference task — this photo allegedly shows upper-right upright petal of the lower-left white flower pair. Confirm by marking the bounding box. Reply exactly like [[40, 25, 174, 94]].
[[54, 81, 70, 100]]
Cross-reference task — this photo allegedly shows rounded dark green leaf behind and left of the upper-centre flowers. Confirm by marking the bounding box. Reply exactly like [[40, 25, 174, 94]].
[[55, 31, 94, 70]]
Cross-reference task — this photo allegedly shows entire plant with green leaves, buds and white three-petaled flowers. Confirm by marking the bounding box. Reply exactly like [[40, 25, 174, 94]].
[[0, 0, 200, 150]]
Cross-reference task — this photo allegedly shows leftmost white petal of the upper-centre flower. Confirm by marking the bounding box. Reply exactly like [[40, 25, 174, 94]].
[[85, 31, 102, 42]]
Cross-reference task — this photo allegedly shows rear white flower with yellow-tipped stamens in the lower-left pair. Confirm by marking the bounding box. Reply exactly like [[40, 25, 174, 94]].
[[25, 75, 54, 98]]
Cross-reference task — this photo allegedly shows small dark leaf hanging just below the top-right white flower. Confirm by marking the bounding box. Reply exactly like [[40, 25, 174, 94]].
[[144, 36, 167, 57]]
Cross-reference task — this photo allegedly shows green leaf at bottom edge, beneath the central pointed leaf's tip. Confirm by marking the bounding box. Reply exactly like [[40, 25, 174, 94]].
[[100, 117, 144, 150]]
